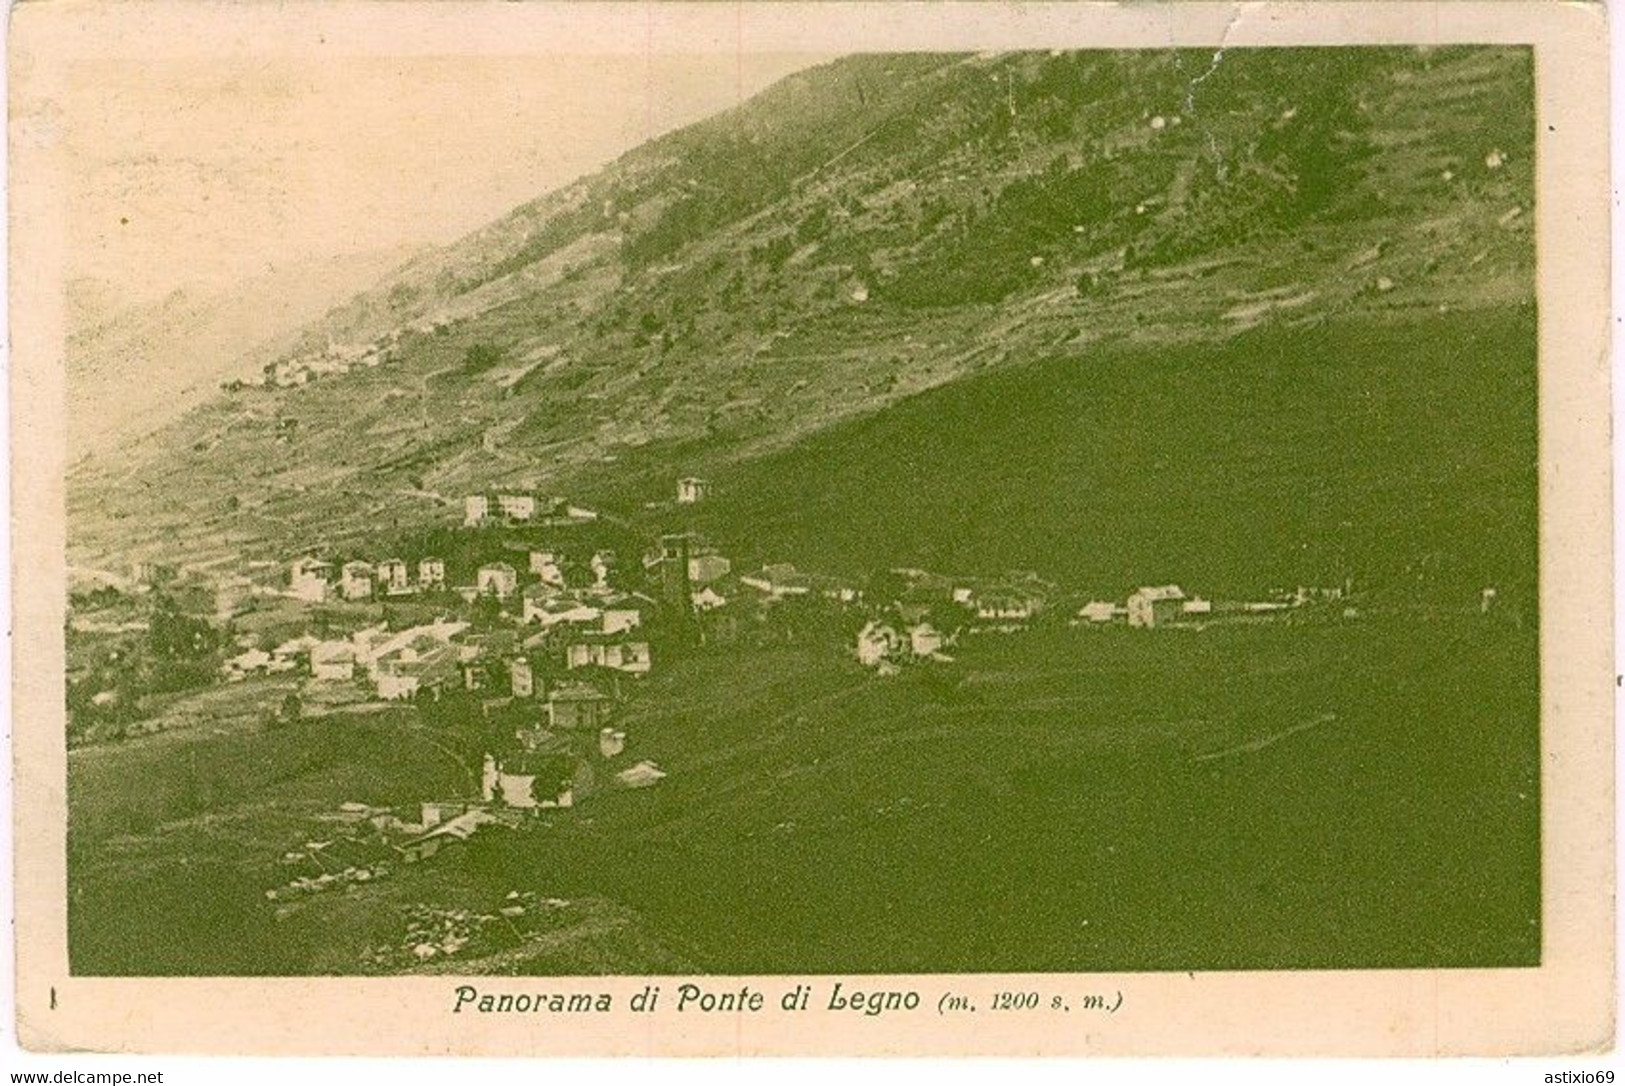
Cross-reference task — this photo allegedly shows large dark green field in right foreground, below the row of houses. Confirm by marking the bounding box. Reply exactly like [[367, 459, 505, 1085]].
[[490, 619, 1539, 972]]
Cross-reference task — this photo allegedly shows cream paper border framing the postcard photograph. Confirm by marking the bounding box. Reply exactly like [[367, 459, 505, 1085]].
[[10, 0, 1615, 1055]]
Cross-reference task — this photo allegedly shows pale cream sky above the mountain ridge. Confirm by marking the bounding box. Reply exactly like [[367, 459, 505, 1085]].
[[60, 54, 827, 302]]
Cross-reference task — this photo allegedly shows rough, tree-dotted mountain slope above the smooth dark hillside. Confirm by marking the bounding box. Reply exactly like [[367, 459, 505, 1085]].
[[70, 49, 1534, 585]]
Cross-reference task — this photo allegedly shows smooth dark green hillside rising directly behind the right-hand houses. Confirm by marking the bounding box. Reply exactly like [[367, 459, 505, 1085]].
[[650, 307, 1537, 603]]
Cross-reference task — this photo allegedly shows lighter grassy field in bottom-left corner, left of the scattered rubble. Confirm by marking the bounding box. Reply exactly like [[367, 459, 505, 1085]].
[[68, 705, 466, 975]]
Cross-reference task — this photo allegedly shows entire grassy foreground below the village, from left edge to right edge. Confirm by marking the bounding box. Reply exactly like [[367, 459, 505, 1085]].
[[70, 615, 1541, 974]]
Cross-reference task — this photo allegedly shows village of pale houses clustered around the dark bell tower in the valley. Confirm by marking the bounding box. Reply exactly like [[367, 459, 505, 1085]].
[[70, 478, 1378, 956]]
